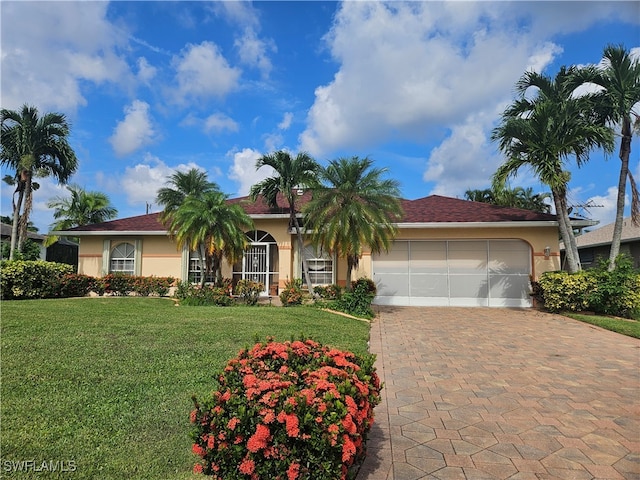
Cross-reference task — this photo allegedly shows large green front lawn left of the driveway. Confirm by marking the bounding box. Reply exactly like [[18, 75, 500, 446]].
[[0, 298, 369, 480]]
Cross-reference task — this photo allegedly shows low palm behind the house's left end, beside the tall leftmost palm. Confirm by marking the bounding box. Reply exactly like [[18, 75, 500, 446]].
[[46, 185, 118, 244]]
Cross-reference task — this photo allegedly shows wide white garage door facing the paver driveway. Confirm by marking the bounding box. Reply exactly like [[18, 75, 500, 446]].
[[373, 240, 531, 307]]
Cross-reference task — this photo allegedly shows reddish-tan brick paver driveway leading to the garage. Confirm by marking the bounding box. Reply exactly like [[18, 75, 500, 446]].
[[358, 307, 640, 480]]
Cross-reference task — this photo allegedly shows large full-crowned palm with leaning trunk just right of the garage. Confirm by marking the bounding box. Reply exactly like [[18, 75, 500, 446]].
[[492, 67, 613, 272]]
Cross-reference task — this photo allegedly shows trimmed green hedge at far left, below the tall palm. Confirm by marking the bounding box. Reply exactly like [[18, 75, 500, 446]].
[[0, 260, 74, 300]]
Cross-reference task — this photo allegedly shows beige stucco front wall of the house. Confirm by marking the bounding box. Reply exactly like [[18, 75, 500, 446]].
[[72, 218, 560, 288]]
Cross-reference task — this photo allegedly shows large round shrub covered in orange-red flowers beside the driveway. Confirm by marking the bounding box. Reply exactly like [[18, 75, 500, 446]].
[[191, 339, 381, 480]]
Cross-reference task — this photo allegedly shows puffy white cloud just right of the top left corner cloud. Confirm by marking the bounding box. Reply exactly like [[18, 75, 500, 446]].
[[171, 41, 240, 103]]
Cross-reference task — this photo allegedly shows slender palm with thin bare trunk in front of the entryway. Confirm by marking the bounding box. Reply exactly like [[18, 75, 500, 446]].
[[250, 150, 320, 293]]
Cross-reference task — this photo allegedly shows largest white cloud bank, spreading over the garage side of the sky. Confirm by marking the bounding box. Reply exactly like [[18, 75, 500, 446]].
[[298, 2, 632, 195]]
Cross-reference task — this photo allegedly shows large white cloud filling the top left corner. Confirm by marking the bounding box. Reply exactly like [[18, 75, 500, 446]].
[[0, 2, 132, 110]]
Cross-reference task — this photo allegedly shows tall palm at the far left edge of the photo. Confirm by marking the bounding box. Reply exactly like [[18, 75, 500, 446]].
[[0, 104, 78, 259]]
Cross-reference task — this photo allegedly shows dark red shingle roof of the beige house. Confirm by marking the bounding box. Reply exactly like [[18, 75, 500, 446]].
[[55, 191, 557, 235]]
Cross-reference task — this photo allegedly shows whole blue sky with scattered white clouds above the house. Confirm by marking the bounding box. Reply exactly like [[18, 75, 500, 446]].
[[0, 1, 640, 233]]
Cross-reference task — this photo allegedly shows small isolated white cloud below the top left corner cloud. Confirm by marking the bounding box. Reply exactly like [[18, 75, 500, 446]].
[[109, 100, 156, 157]]
